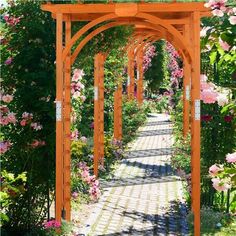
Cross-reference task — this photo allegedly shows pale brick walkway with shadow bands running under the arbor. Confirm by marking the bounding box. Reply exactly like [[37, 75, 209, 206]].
[[80, 114, 188, 236]]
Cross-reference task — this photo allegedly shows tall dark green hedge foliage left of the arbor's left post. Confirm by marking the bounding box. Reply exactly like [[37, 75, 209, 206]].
[[1, 0, 55, 231]]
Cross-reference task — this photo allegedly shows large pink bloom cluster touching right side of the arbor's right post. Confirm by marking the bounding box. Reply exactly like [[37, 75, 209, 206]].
[[200, 74, 219, 104]]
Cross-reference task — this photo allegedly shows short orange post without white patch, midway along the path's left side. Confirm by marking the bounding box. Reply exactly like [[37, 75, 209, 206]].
[[114, 83, 122, 141]]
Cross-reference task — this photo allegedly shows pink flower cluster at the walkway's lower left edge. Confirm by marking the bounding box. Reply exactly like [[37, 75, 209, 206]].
[[79, 162, 101, 201]]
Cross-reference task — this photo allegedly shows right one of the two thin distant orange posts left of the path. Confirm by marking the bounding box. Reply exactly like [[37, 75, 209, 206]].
[[137, 48, 143, 105]]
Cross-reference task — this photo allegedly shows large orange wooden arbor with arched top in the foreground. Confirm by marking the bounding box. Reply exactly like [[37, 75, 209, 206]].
[[42, 1, 208, 235]]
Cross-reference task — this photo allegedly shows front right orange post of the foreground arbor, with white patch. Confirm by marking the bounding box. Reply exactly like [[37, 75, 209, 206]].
[[191, 12, 200, 236]]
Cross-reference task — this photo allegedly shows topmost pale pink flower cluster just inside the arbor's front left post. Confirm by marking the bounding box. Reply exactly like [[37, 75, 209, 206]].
[[71, 69, 86, 101]]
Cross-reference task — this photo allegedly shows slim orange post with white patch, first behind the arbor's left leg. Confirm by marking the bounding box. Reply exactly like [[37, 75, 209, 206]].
[[93, 54, 100, 177]]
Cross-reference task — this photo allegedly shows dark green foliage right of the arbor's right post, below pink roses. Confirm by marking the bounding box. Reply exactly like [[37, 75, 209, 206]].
[[201, 104, 236, 206]]
